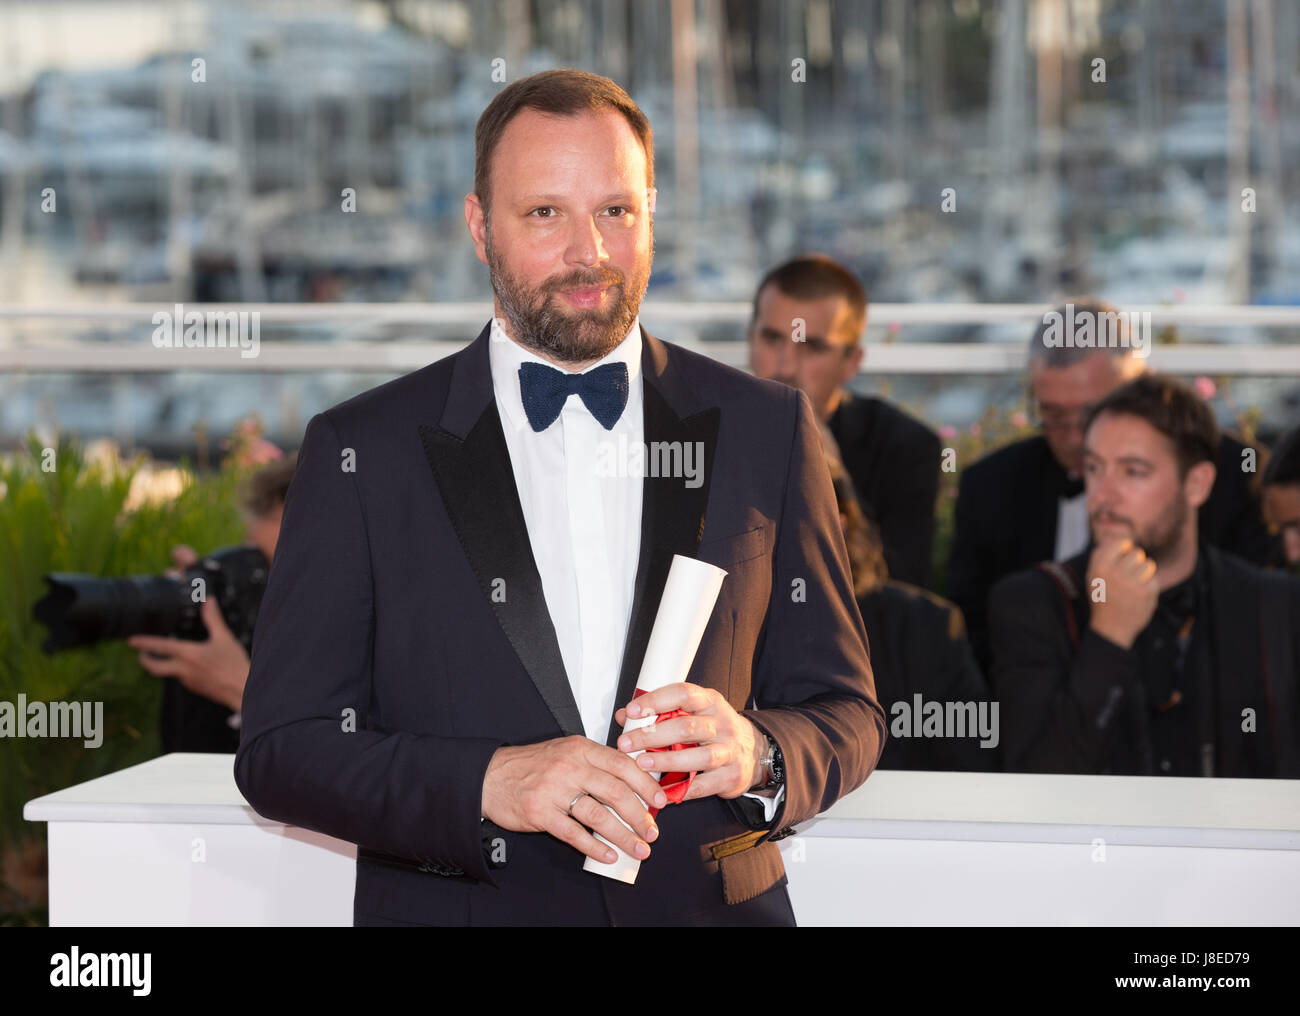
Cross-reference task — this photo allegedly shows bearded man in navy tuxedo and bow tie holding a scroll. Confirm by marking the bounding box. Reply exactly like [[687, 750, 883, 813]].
[[235, 70, 884, 925]]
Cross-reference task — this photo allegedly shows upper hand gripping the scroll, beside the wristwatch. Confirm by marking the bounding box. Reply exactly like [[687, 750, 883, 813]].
[[614, 682, 763, 802]]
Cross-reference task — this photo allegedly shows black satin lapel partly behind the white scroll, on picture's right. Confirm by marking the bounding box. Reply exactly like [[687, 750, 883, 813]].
[[605, 378, 722, 747]]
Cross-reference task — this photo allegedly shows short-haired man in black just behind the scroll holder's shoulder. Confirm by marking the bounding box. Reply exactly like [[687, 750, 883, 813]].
[[746, 255, 940, 587]]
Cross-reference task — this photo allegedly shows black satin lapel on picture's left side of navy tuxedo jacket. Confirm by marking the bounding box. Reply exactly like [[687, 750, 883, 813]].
[[420, 400, 585, 735]]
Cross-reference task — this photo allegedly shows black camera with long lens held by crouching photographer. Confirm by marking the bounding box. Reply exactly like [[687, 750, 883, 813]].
[[31, 547, 270, 655]]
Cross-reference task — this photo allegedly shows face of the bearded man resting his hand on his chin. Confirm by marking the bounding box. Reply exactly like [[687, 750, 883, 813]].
[[1083, 413, 1214, 565]]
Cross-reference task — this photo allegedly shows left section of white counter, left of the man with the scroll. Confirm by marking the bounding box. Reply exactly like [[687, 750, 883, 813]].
[[22, 754, 356, 926]]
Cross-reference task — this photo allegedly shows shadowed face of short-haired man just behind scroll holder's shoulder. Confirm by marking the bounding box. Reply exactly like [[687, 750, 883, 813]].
[[748, 283, 862, 421]]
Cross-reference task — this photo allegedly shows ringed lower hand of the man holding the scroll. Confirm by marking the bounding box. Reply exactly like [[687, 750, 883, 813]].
[[482, 735, 668, 863]]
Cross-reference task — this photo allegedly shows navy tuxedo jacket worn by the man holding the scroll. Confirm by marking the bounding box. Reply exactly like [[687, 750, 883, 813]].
[[235, 327, 885, 925]]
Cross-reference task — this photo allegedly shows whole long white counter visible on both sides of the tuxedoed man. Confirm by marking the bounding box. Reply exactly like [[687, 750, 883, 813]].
[[23, 755, 1300, 926]]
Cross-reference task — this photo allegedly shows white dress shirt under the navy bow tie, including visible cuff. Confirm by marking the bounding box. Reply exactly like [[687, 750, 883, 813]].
[[489, 317, 785, 821]]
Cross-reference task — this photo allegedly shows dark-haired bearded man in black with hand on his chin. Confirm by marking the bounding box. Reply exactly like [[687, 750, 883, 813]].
[[989, 375, 1300, 778]]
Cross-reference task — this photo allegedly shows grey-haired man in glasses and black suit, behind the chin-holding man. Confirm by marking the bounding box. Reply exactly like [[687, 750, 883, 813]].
[[948, 300, 1268, 667]]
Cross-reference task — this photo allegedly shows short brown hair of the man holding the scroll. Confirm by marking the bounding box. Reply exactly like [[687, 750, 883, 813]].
[[475, 68, 654, 216]]
